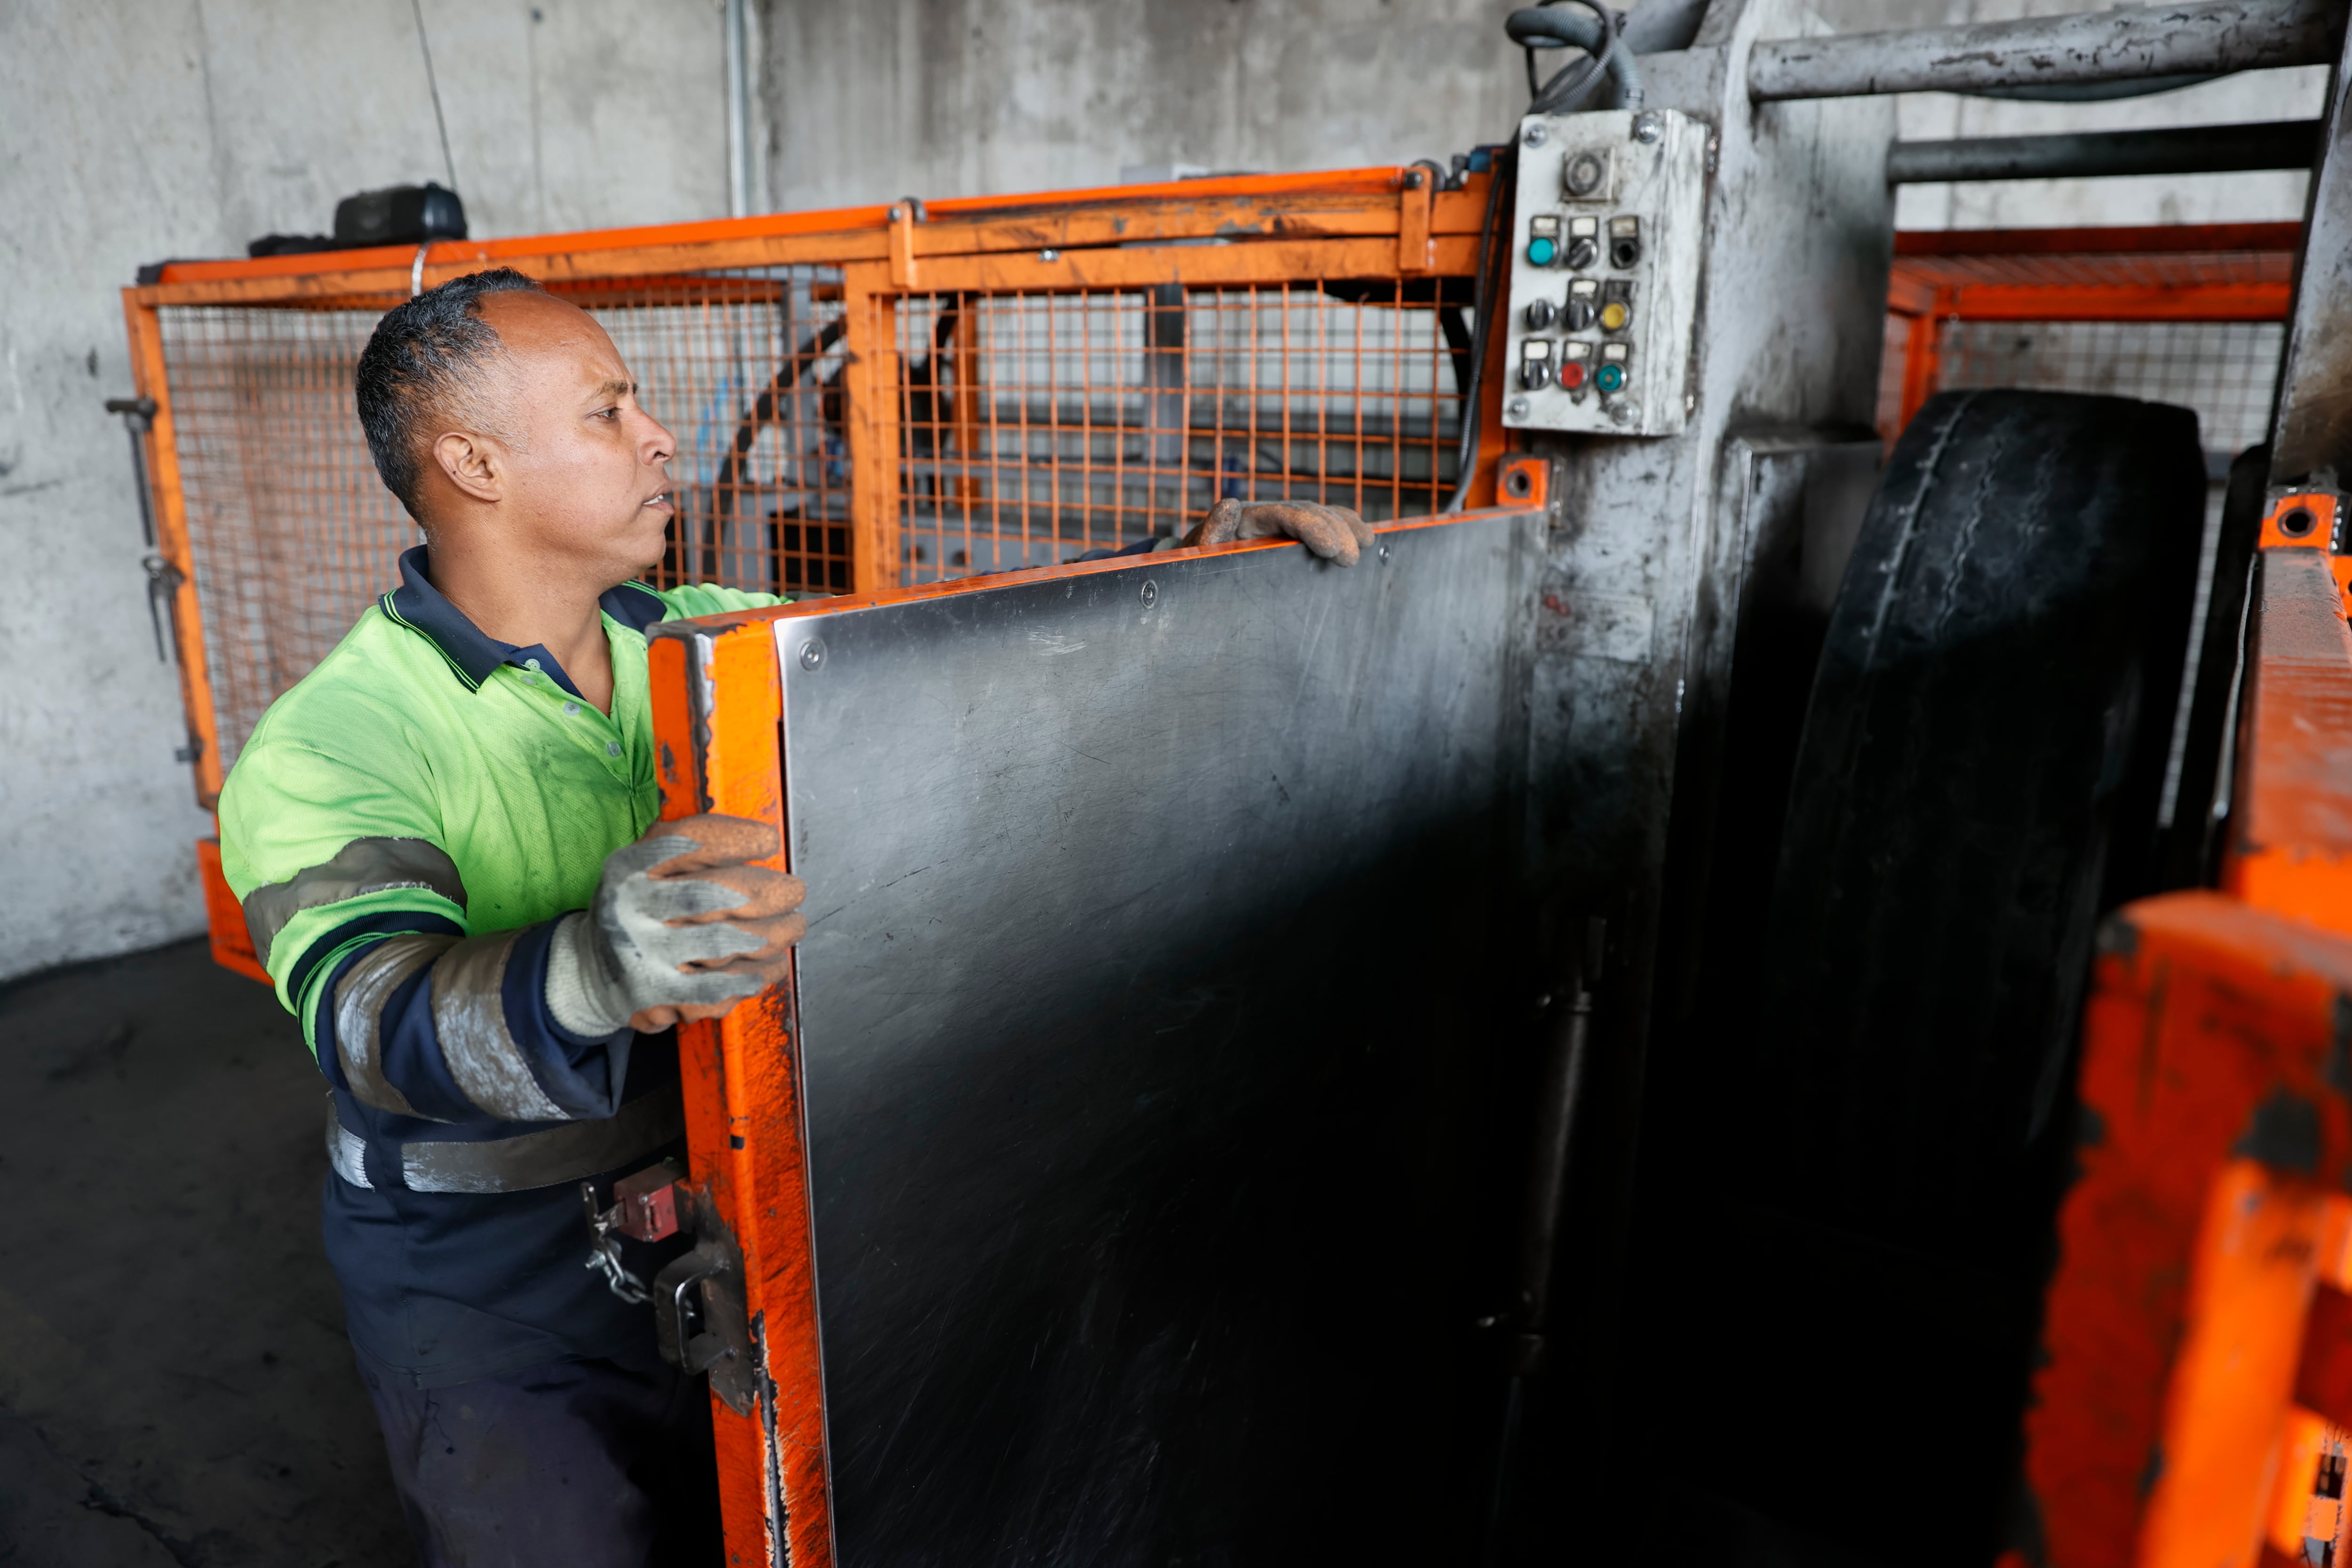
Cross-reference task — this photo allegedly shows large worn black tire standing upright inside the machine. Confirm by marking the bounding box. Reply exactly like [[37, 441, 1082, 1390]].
[[1766, 390, 2206, 1262]]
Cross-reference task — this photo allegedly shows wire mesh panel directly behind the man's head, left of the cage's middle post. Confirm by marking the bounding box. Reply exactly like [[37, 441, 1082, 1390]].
[[160, 282, 849, 769]]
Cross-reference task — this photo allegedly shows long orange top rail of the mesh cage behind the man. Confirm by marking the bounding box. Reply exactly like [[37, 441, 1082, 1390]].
[[139, 169, 1491, 306]]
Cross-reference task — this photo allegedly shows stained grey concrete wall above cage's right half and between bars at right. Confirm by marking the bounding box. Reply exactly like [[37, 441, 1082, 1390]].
[[762, 0, 2326, 228]]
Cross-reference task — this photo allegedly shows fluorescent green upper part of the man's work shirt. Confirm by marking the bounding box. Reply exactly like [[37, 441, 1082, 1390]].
[[221, 548, 783, 1034]]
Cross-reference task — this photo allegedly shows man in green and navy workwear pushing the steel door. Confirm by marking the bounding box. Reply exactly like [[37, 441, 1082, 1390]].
[[221, 268, 1369, 1568]]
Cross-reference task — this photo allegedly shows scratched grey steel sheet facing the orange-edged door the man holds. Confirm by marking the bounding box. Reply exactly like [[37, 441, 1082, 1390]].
[[779, 517, 1541, 1568]]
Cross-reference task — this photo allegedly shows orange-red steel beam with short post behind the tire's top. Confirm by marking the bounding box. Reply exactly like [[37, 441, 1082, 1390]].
[[1886, 223, 2303, 430]]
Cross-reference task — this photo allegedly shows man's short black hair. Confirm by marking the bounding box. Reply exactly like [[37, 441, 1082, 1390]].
[[353, 266, 539, 522]]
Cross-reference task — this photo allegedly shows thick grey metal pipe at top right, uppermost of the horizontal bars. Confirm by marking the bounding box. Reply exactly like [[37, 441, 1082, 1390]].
[[1748, 0, 2343, 103]]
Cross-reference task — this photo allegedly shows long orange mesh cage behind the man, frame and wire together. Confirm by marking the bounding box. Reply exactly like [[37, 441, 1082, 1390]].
[[125, 169, 1501, 806]]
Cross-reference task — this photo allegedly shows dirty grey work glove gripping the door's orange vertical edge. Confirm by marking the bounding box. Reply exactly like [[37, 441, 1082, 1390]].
[[548, 816, 809, 1037]]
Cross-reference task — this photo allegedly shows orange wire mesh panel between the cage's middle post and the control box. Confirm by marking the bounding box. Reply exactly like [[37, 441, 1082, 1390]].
[[877, 280, 1470, 583]]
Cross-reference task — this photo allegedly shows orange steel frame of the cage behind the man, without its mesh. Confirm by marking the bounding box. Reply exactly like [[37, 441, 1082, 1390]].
[[122, 167, 1508, 978]]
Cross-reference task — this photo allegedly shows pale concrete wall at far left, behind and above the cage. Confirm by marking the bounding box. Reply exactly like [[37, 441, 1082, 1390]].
[[0, 0, 727, 978]]
